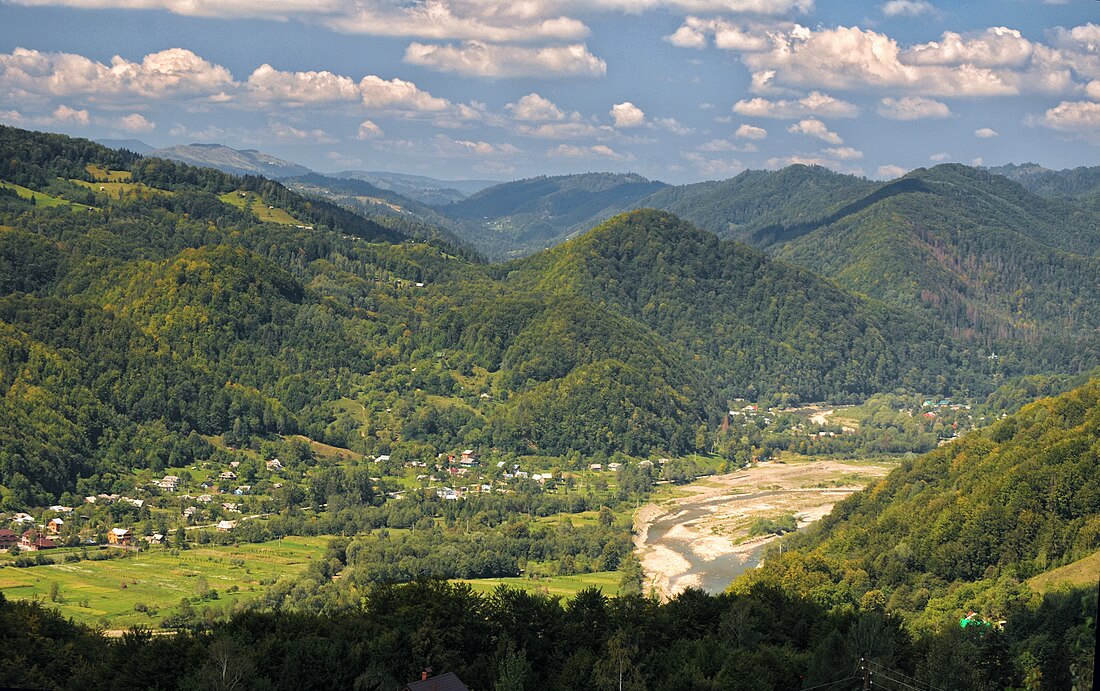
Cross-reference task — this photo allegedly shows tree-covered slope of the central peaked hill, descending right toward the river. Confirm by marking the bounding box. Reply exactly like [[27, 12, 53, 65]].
[[499, 210, 970, 401]]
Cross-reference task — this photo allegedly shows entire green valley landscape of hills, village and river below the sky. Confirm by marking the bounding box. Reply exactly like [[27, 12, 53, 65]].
[[0, 127, 1100, 689]]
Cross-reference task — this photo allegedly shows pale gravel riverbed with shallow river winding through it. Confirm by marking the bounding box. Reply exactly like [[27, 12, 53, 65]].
[[635, 460, 891, 597]]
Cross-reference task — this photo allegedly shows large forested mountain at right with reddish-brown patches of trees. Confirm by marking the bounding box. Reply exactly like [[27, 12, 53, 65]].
[[771, 165, 1100, 371]]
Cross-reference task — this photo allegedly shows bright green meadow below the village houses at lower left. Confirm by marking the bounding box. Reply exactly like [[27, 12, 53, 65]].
[[0, 537, 331, 629]]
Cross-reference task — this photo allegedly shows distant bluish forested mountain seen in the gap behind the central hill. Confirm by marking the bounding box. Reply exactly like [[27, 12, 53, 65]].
[[436, 173, 666, 259]]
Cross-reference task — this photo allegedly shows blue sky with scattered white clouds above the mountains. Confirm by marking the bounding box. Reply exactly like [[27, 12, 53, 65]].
[[0, 0, 1100, 184]]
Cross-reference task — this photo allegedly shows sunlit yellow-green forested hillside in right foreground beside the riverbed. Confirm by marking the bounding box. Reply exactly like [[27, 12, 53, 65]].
[[740, 380, 1100, 625]]
